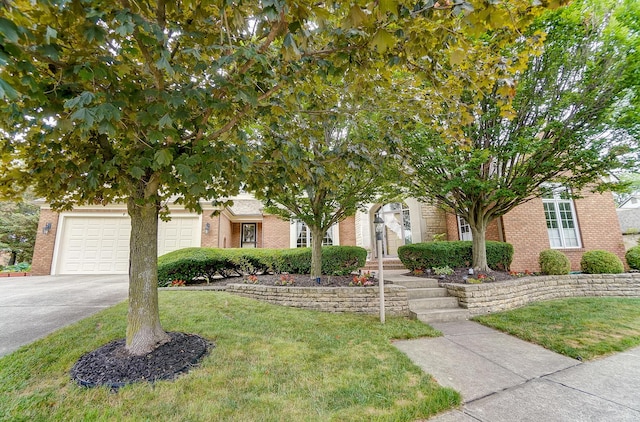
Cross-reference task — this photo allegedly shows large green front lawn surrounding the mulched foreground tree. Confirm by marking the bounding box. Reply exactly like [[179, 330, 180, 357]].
[[0, 291, 460, 421]]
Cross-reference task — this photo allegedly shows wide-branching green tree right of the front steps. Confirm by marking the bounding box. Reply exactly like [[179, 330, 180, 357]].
[[406, 2, 640, 271]]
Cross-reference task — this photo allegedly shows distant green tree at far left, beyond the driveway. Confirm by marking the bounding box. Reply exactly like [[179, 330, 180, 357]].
[[0, 201, 40, 265]]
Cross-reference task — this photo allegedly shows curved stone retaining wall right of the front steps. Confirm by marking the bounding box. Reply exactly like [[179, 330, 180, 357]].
[[443, 273, 640, 316]]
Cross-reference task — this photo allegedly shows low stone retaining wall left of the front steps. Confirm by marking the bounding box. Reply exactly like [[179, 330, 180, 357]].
[[226, 284, 409, 316]]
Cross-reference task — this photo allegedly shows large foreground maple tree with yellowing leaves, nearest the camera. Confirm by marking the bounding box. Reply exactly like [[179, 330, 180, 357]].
[[0, 0, 560, 354]]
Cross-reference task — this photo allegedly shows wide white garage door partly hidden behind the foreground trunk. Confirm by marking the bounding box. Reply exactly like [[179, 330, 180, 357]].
[[54, 215, 200, 274]]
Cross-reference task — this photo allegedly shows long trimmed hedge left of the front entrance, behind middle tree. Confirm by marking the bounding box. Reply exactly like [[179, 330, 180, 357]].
[[158, 246, 367, 287]]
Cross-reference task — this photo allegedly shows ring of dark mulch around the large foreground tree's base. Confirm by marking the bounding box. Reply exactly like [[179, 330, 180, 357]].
[[71, 332, 213, 390]]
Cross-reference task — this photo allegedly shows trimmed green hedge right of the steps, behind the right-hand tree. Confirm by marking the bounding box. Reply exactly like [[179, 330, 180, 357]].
[[398, 240, 513, 271]]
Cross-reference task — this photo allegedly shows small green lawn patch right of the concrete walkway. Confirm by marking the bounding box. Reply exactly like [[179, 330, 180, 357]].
[[474, 298, 640, 360]]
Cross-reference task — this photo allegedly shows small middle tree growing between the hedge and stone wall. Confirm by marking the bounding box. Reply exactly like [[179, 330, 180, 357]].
[[248, 76, 393, 278]]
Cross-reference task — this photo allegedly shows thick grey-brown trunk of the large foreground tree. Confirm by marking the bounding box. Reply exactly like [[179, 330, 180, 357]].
[[126, 198, 170, 355]]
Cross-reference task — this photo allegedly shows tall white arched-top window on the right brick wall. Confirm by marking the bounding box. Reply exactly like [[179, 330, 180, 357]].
[[542, 186, 580, 248]]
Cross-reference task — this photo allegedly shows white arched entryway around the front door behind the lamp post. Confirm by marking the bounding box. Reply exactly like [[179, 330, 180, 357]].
[[371, 202, 412, 257]]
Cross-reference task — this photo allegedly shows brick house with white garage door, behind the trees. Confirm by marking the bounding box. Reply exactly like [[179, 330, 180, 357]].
[[32, 192, 625, 275]]
